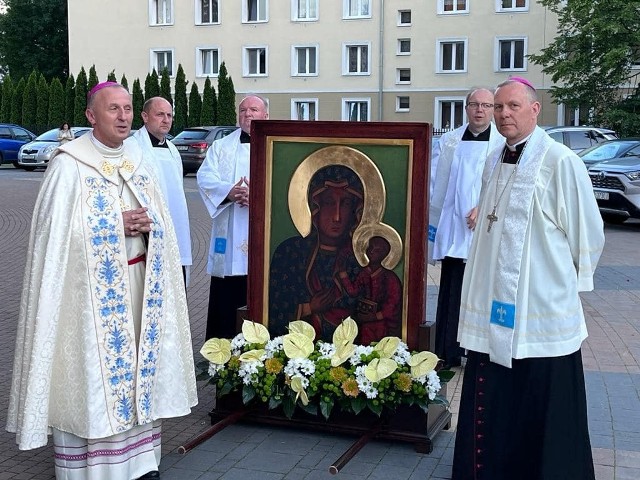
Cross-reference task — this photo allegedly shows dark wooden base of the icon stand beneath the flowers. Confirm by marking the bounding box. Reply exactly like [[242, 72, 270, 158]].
[[209, 384, 451, 453]]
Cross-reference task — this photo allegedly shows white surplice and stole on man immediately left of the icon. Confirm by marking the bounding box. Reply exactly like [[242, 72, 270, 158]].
[[198, 128, 249, 278]]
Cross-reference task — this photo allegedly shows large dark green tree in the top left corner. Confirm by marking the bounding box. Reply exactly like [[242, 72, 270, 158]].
[[0, 0, 69, 79]]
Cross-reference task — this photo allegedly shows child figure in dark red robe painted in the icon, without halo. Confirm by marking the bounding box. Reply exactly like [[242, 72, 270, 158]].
[[338, 236, 402, 345]]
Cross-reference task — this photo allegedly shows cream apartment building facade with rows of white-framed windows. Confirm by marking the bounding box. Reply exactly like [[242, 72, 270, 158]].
[[69, 0, 572, 128]]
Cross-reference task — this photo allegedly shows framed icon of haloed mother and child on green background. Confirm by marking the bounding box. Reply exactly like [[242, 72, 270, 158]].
[[248, 120, 431, 349]]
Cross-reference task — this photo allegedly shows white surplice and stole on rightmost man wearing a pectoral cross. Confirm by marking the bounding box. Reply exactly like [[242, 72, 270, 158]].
[[458, 128, 604, 367]]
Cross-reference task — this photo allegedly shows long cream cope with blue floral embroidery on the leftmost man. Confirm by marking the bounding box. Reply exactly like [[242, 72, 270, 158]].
[[7, 133, 197, 462]]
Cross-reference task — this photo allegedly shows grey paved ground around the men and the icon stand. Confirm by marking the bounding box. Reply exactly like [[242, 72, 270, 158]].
[[0, 167, 640, 480]]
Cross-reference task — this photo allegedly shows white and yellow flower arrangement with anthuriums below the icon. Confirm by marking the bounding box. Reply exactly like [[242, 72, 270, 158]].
[[198, 318, 453, 418]]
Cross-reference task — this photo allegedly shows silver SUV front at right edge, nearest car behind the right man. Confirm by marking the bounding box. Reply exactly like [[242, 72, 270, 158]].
[[589, 156, 640, 223]]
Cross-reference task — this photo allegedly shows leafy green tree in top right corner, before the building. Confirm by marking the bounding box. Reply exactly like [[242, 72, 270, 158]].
[[530, 0, 640, 131]]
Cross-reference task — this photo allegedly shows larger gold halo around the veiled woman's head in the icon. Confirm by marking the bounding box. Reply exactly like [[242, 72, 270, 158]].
[[288, 145, 386, 237]]
